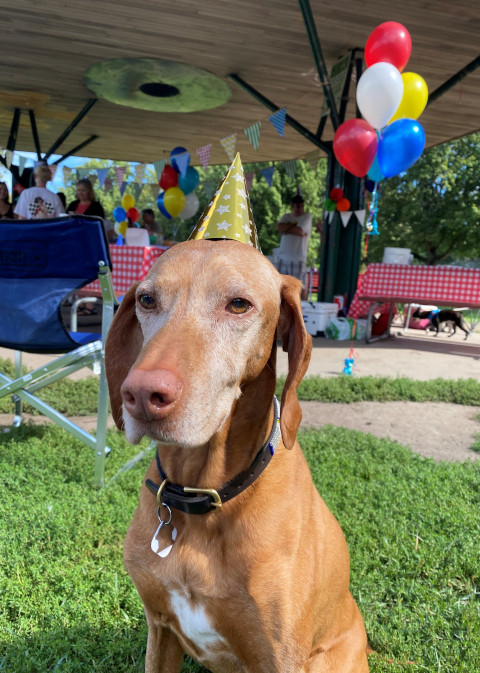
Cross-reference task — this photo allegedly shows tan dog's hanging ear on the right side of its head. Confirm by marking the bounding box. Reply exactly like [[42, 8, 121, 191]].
[[278, 276, 312, 449]]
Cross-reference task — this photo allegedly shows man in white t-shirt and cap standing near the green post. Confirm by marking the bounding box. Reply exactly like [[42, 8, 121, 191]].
[[276, 194, 312, 299]]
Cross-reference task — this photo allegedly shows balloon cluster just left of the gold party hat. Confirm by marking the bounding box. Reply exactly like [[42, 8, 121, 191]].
[[157, 147, 200, 220]]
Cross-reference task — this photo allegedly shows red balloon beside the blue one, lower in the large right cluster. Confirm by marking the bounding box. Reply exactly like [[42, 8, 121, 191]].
[[333, 119, 377, 178]]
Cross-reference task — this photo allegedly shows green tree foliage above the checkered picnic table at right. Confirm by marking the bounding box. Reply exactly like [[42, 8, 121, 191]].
[[368, 133, 480, 264]]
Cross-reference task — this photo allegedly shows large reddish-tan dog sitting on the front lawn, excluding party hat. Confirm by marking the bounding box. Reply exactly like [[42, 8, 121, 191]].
[[105, 240, 368, 673]]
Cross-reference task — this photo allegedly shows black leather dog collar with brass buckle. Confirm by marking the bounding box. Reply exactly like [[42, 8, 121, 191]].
[[145, 396, 281, 514]]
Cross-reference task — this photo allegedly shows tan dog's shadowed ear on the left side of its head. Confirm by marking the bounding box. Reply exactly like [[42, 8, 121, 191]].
[[105, 283, 143, 430]]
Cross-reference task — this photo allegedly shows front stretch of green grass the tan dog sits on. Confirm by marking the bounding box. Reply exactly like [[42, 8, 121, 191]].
[[0, 426, 480, 673]]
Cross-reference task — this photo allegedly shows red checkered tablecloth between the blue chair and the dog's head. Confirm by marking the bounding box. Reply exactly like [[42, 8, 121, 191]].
[[82, 245, 167, 297]]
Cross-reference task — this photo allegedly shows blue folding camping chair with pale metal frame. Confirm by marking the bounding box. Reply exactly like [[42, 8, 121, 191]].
[[0, 215, 116, 487]]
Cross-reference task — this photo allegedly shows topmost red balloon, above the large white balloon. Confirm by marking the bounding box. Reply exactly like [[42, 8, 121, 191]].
[[365, 21, 412, 72]]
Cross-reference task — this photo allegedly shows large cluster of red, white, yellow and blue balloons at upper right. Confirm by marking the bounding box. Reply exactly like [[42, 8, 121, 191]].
[[333, 21, 428, 182]]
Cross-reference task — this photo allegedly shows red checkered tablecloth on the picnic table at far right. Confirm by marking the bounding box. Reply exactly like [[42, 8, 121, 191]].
[[348, 264, 480, 317]]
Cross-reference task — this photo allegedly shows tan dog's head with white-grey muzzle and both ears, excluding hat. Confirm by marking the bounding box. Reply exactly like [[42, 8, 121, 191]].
[[105, 240, 311, 448]]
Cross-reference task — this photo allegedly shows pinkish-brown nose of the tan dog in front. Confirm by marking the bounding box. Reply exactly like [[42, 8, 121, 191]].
[[120, 368, 182, 421]]
